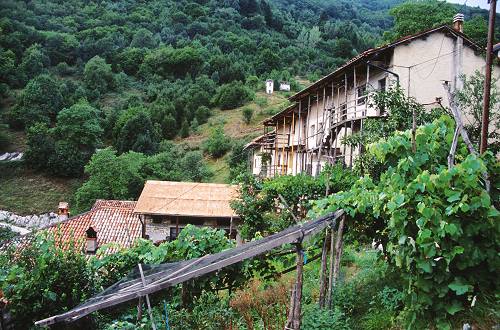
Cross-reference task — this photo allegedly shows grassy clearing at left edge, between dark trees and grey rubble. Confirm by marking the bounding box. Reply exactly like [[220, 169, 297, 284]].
[[0, 163, 82, 215]]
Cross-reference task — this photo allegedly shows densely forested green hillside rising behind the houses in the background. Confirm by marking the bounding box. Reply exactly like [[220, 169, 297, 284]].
[[0, 0, 492, 213]]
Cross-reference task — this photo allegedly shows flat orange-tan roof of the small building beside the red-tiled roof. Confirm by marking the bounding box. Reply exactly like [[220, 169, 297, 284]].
[[134, 180, 237, 218]]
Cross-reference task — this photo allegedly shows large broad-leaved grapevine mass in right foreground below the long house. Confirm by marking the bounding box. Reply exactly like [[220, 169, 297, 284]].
[[315, 117, 500, 327]]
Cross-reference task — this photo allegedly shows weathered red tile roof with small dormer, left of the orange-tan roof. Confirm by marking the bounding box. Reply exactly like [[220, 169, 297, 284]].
[[47, 200, 142, 253]]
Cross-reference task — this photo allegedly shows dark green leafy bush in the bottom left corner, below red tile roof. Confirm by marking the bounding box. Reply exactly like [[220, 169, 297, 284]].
[[0, 234, 94, 329]]
